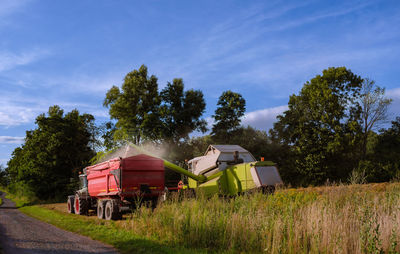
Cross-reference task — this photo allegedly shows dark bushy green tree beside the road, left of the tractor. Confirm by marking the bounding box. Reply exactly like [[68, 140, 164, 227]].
[[7, 106, 96, 199]]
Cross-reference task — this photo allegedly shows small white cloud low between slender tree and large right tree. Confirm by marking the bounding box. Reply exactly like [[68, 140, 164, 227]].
[[242, 105, 288, 130]]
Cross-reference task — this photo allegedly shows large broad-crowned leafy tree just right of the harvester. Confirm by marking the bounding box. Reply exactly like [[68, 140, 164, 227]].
[[271, 67, 362, 185]]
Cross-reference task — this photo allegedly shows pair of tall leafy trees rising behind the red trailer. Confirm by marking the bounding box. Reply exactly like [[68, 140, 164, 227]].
[[104, 65, 207, 148]]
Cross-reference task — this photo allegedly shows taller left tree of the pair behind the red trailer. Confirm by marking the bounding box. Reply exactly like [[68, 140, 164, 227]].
[[103, 65, 161, 144]]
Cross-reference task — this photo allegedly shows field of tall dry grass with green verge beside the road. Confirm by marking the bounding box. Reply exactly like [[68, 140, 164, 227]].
[[17, 183, 400, 253]]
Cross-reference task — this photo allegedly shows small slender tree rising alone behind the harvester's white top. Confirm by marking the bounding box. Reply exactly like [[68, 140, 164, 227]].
[[211, 91, 246, 143]]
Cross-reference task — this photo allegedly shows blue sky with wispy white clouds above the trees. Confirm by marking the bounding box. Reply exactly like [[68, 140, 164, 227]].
[[0, 0, 400, 166]]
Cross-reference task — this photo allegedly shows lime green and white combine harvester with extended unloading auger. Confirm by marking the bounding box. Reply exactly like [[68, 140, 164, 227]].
[[143, 145, 282, 196]]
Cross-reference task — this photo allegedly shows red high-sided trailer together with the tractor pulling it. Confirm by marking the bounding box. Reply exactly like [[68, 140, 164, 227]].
[[68, 154, 165, 220]]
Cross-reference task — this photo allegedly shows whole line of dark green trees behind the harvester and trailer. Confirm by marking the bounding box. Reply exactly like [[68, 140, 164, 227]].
[[0, 65, 400, 199]]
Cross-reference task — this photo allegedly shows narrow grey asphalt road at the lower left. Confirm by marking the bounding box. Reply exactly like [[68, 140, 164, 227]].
[[0, 192, 118, 254]]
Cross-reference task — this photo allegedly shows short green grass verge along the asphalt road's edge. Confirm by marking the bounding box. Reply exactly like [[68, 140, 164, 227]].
[[19, 205, 207, 253]]
